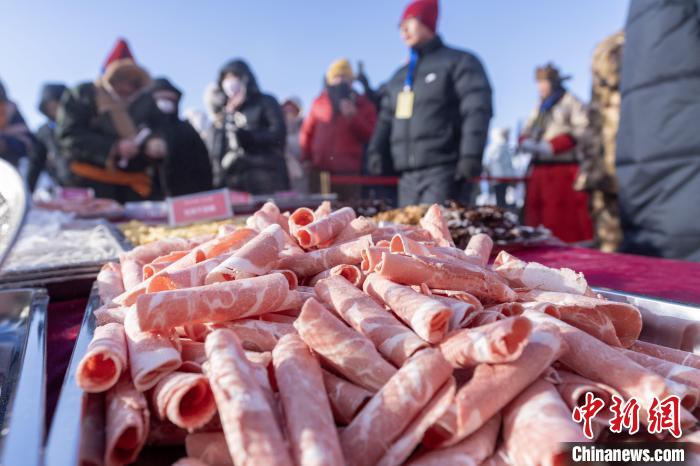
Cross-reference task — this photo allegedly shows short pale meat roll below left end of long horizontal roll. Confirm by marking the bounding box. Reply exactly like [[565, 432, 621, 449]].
[[124, 308, 182, 392]]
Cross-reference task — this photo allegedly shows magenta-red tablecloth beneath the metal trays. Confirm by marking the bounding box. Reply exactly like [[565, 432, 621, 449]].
[[46, 246, 700, 428]]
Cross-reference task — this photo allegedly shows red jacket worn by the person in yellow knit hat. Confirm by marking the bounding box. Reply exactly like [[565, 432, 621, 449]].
[[299, 91, 377, 174]]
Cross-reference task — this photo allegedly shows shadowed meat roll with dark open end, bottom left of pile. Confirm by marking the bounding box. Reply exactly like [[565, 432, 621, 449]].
[[104, 377, 150, 466]]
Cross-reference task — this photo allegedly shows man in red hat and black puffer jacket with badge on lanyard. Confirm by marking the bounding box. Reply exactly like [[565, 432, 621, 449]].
[[367, 0, 492, 206]]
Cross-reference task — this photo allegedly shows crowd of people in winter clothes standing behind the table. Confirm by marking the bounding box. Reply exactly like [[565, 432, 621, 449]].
[[0, 0, 700, 260]]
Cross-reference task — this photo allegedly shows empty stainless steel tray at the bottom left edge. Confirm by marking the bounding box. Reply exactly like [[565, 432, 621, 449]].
[[0, 289, 49, 466]]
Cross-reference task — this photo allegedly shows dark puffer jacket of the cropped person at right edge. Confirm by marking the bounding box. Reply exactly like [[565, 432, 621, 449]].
[[616, 0, 700, 261]]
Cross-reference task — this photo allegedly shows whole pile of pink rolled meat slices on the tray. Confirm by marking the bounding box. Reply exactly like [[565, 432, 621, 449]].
[[77, 203, 700, 466]]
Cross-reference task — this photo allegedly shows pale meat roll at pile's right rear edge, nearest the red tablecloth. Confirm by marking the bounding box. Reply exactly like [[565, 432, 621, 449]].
[[493, 251, 596, 297]]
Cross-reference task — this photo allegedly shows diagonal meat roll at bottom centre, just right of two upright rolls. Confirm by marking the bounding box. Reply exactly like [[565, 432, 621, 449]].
[[340, 348, 452, 466]]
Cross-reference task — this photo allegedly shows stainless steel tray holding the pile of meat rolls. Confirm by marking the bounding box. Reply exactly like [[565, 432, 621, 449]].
[[45, 287, 700, 466]]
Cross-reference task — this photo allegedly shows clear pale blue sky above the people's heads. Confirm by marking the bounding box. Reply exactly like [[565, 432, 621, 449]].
[[0, 0, 628, 134]]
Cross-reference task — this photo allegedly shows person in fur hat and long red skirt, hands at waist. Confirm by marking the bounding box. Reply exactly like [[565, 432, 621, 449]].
[[520, 64, 593, 242]]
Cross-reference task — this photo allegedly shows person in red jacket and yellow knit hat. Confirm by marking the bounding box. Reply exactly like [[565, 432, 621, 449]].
[[299, 59, 377, 200]]
